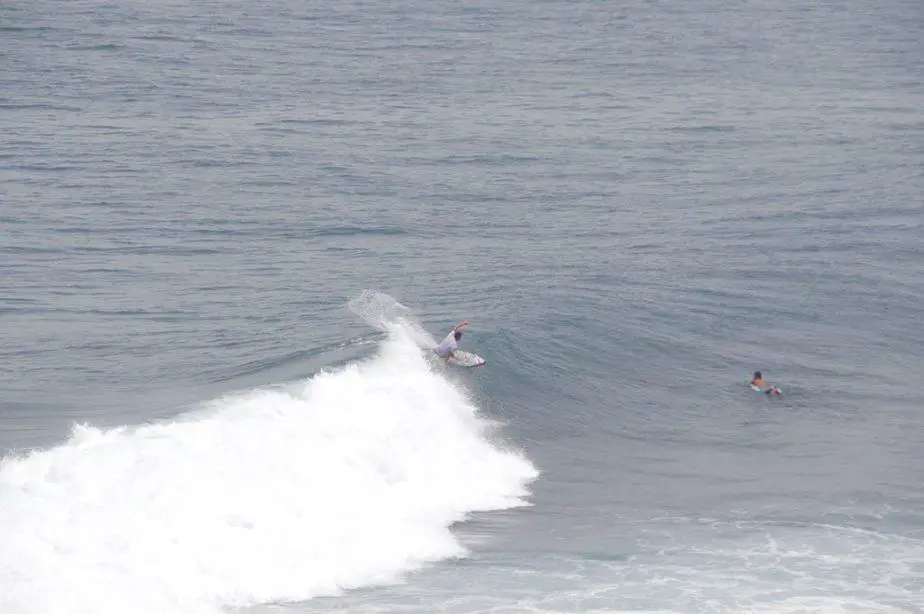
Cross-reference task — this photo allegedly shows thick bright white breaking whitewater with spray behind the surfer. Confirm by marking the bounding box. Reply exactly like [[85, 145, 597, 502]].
[[0, 293, 538, 614]]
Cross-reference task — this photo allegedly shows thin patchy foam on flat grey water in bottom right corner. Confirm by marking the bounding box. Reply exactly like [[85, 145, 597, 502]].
[[280, 516, 924, 614]]
